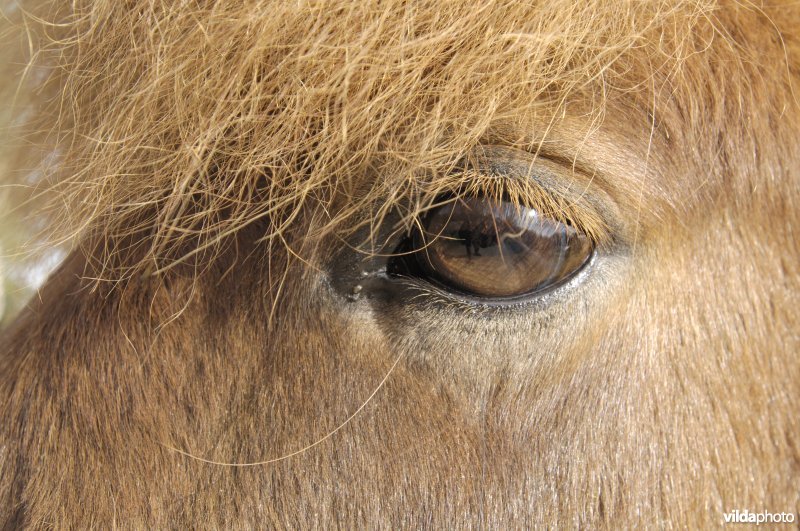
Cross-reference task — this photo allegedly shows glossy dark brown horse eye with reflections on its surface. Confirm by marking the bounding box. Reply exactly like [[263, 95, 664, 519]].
[[389, 197, 594, 299]]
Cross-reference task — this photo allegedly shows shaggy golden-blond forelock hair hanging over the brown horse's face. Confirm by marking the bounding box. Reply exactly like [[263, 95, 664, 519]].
[[3, 0, 796, 280]]
